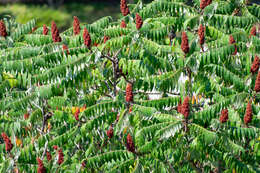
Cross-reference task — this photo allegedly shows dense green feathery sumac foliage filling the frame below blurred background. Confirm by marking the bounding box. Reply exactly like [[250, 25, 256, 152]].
[[0, 0, 260, 173]]
